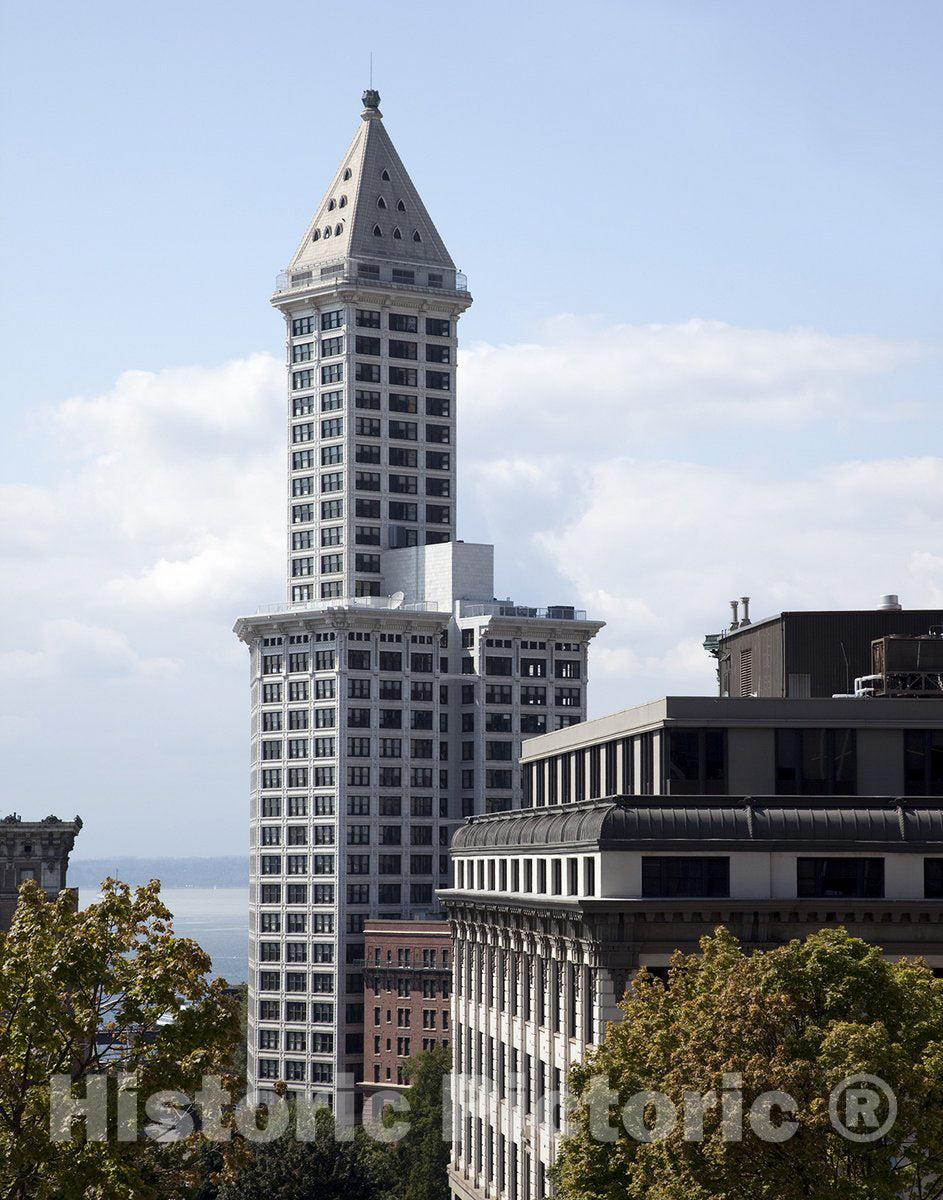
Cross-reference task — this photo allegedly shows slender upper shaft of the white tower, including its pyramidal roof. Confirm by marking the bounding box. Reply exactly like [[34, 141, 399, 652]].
[[272, 91, 472, 602]]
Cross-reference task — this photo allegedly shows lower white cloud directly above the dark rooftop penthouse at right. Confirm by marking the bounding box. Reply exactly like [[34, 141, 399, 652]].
[[527, 457, 943, 710]]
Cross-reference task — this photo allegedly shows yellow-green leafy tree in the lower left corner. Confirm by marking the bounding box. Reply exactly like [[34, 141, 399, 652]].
[[0, 880, 238, 1200]]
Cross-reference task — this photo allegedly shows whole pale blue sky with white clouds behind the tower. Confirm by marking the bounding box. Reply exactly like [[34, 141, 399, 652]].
[[0, 0, 943, 858]]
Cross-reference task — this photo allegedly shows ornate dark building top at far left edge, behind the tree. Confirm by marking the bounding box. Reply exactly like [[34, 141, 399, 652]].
[[0, 812, 82, 931]]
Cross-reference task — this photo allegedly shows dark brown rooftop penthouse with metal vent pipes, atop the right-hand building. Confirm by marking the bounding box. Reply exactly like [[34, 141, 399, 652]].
[[704, 595, 943, 700]]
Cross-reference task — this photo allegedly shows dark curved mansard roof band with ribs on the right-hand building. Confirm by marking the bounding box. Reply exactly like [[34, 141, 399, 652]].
[[452, 796, 943, 851]]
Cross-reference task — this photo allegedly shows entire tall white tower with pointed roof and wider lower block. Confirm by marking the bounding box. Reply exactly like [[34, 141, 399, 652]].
[[235, 91, 600, 1103]]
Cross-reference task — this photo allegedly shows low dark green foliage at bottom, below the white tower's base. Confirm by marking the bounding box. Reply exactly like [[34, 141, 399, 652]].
[[217, 1109, 394, 1200]]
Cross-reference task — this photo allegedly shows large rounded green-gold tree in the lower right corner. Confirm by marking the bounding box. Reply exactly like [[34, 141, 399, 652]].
[[554, 929, 943, 1200]]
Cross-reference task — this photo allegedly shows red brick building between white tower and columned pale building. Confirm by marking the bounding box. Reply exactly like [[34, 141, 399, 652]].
[[364, 920, 452, 1093]]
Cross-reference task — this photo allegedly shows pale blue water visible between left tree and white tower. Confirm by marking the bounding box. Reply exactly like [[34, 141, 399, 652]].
[[79, 888, 248, 984]]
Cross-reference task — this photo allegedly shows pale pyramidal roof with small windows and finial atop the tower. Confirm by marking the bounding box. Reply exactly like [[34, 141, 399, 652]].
[[289, 90, 455, 271]]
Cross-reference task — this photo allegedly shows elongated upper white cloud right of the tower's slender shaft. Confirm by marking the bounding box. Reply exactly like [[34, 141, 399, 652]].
[[460, 316, 924, 454]]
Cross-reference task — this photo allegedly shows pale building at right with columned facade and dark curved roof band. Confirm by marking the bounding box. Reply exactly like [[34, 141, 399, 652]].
[[442, 696, 943, 1200]]
